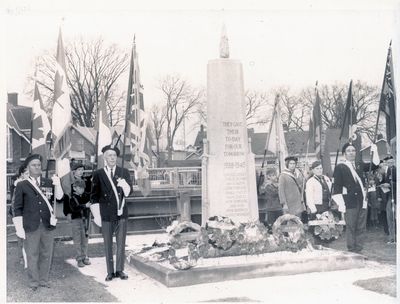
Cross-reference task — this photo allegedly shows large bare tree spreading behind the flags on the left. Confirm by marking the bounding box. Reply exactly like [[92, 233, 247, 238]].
[[32, 39, 129, 127]]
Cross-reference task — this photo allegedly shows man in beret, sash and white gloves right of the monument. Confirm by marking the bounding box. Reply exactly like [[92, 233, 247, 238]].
[[332, 143, 379, 252]]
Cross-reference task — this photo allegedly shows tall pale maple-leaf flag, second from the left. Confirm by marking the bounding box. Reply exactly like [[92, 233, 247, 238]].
[[51, 29, 72, 176]]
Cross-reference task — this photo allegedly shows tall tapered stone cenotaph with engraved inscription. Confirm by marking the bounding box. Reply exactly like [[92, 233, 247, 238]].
[[202, 27, 258, 225]]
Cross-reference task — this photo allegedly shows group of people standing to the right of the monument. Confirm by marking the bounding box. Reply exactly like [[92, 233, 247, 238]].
[[258, 143, 396, 252]]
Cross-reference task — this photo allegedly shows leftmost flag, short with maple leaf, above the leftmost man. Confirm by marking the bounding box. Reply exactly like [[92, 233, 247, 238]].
[[31, 82, 51, 164]]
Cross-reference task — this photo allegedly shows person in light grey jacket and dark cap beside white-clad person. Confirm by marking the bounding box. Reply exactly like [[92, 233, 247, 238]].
[[279, 156, 305, 218]]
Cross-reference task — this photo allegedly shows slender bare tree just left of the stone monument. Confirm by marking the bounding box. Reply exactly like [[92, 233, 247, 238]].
[[159, 75, 203, 160]]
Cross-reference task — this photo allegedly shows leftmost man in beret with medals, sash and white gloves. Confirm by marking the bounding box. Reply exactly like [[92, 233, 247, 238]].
[[13, 154, 63, 290]]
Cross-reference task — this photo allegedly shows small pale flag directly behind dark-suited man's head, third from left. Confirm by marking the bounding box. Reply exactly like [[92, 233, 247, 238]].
[[95, 87, 112, 168]]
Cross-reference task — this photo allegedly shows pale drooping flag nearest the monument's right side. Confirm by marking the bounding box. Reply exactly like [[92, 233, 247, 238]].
[[265, 95, 288, 172]]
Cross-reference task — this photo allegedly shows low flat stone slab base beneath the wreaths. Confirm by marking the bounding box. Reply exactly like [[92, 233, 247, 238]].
[[127, 248, 367, 287]]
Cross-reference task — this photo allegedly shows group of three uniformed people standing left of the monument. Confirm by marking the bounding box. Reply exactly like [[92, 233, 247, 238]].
[[9, 145, 132, 290]]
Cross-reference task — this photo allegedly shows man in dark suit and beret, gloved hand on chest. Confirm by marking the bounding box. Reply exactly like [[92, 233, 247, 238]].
[[91, 145, 132, 281]]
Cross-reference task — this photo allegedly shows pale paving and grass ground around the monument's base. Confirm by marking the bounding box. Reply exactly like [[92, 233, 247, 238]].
[[7, 226, 396, 304]]
